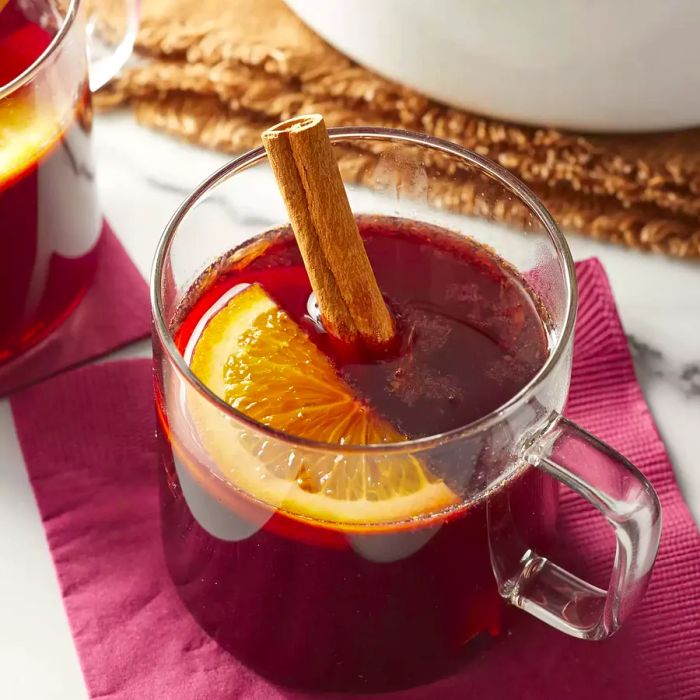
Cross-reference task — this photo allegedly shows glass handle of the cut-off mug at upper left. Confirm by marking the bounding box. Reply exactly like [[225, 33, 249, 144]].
[[87, 0, 141, 92]]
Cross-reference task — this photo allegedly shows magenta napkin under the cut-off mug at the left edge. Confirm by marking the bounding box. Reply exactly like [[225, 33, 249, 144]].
[[0, 222, 151, 396]]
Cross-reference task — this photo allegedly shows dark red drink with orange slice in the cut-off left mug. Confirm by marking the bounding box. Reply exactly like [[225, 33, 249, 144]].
[[0, 0, 100, 363]]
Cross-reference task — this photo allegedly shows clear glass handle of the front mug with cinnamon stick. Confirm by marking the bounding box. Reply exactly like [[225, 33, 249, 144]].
[[488, 416, 661, 639]]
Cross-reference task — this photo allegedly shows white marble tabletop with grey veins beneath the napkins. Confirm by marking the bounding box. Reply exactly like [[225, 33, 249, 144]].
[[0, 114, 700, 700]]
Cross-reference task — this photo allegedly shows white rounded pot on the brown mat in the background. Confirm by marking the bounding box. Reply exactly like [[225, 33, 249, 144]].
[[287, 0, 700, 131]]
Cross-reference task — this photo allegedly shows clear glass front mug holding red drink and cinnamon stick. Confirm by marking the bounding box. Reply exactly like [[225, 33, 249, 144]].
[[151, 128, 661, 690]]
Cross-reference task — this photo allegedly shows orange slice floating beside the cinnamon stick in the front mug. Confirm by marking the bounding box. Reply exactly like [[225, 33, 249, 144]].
[[188, 285, 457, 525]]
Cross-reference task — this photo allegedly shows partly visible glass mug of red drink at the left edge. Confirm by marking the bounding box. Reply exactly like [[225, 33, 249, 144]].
[[0, 0, 138, 373]]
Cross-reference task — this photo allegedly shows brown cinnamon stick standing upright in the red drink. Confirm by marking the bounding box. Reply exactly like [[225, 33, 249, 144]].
[[262, 114, 395, 345]]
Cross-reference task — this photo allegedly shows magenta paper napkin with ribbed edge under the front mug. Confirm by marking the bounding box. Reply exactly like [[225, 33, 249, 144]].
[[12, 260, 700, 700]]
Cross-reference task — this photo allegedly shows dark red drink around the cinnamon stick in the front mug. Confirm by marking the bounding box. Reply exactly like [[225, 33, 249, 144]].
[[157, 217, 556, 691]]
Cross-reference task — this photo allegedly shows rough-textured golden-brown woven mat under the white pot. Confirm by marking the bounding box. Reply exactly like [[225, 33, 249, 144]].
[[98, 0, 700, 258]]
